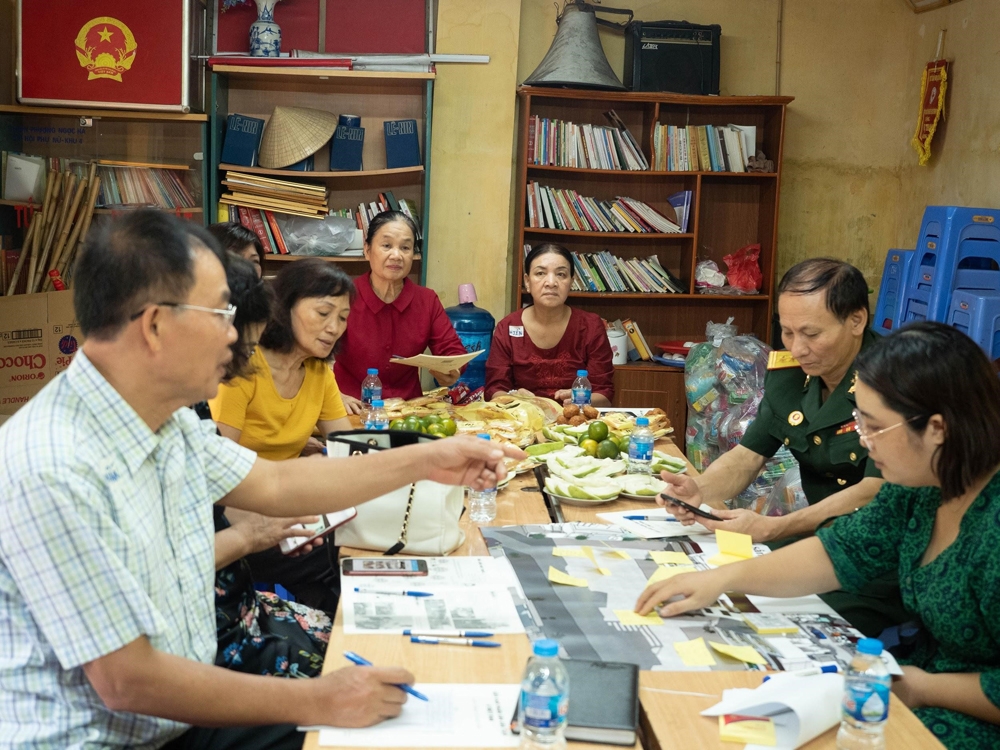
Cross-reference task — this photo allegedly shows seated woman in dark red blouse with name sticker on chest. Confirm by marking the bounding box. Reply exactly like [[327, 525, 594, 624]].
[[486, 243, 615, 406]]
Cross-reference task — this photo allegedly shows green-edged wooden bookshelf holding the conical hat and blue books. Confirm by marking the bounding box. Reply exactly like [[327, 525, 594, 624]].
[[206, 65, 434, 284]]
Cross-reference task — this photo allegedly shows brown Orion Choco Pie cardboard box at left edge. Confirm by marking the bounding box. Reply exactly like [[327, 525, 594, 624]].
[[0, 291, 82, 415]]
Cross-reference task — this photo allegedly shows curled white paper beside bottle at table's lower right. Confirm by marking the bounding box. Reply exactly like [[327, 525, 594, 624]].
[[701, 674, 844, 748]]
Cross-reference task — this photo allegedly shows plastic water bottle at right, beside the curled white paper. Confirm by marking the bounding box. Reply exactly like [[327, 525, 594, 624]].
[[837, 638, 892, 750]]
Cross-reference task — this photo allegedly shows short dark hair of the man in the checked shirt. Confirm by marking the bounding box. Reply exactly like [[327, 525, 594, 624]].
[[73, 209, 227, 341]]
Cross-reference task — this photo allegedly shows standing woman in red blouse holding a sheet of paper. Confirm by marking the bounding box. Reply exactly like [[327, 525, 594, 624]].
[[333, 211, 465, 414]]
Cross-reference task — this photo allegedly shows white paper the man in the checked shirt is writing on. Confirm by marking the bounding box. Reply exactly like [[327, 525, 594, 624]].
[[308, 684, 520, 747]]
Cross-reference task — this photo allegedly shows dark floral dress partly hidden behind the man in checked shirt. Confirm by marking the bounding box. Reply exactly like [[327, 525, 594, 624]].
[[215, 506, 333, 677]]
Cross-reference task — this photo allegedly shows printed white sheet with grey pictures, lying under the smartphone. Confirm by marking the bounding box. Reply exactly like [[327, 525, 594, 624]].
[[340, 557, 524, 633]]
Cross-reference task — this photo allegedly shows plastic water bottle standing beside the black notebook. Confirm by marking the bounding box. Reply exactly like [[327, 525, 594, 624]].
[[520, 638, 569, 750]]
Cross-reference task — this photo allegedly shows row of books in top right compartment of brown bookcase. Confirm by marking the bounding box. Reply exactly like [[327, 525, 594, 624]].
[[653, 125, 757, 172]]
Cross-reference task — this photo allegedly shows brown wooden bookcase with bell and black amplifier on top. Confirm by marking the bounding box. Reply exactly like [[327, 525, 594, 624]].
[[511, 86, 792, 439]]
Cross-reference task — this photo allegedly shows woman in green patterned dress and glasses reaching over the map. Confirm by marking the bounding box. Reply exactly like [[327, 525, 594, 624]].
[[636, 323, 1000, 750]]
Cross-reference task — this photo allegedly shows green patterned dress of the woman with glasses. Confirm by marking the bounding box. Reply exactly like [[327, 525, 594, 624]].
[[817, 474, 1000, 750]]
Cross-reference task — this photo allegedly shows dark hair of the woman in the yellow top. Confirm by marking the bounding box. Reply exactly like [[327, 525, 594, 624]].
[[260, 258, 355, 353]]
